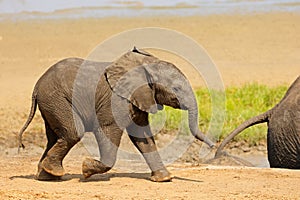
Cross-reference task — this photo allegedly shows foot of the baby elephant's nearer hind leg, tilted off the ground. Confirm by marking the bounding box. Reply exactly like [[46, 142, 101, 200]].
[[42, 156, 65, 176]]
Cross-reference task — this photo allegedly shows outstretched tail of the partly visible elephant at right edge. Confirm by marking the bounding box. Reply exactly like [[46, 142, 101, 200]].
[[215, 109, 272, 158]]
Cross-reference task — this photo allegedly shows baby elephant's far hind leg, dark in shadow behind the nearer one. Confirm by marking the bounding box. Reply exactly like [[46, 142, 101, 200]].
[[36, 120, 59, 180]]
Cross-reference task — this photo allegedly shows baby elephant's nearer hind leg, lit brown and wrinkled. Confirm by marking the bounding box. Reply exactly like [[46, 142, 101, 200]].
[[41, 109, 84, 176]]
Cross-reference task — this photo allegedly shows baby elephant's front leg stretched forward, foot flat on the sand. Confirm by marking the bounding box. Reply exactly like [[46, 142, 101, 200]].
[[127, 123, 172, 182]]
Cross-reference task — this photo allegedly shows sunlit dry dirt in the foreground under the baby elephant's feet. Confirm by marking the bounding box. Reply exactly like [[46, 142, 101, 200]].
[[0, 152, 300, 200]]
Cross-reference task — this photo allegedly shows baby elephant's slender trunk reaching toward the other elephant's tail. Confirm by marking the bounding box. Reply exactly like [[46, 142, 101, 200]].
[[188, 104, 215, 148]]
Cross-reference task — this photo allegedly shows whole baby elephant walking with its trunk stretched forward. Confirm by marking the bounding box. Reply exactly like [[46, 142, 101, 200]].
[[19, 48, 214, 182]]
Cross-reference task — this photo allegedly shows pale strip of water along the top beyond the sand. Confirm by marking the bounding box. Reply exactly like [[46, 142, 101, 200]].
[[0, 0, 300, 20]]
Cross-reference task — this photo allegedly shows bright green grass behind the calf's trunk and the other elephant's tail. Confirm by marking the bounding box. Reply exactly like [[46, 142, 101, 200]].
[[150, 83, 288, 145]]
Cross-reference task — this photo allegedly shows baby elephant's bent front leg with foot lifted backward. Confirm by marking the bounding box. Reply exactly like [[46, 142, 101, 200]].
[[82, 124, 123, 178]]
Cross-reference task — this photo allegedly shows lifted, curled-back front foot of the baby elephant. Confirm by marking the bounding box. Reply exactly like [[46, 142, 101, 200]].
[[82, 158, 111, 178]]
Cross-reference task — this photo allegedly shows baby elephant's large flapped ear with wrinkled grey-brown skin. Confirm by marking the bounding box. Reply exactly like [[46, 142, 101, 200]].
[[105, 63, 157, 113]]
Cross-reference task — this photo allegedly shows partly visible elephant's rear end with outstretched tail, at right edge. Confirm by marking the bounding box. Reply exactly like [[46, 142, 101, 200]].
[[215, 76, 300, 169]]
